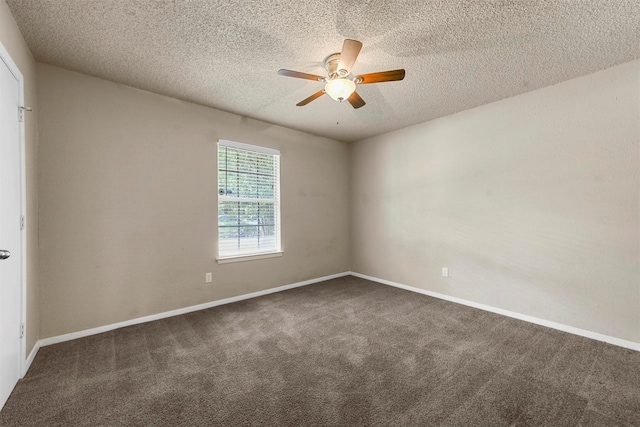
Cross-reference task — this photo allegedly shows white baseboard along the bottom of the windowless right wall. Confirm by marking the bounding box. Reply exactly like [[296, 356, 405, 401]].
[[350, 271, 640, 351]]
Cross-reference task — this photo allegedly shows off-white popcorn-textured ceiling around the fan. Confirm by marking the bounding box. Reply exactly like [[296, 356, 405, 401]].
[[7, 0, 640, 141]]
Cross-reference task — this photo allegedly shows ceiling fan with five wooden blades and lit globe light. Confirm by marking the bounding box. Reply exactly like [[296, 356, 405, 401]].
[[278, 39, 405, 108]]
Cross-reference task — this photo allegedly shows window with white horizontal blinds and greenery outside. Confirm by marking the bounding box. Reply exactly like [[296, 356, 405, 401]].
[[218, 140, 280, 258]]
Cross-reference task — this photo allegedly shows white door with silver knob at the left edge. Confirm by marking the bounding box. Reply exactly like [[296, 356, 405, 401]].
[[0, 45, 22, 408]]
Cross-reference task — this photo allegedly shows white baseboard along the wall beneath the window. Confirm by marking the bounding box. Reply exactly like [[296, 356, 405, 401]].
[[34, 272, 350, 350]]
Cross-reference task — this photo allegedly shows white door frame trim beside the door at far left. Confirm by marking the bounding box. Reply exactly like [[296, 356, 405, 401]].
[[0, 41, 29, 378]]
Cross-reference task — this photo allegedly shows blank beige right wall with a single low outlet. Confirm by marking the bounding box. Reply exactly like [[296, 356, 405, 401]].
[[351, 61, 640, 342]]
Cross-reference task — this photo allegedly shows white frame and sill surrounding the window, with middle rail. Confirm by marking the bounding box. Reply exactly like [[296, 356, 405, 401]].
[[216, 139, 283, 264]]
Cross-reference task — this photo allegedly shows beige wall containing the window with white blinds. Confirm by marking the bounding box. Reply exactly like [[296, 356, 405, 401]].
[[37, 63, 350, 338]]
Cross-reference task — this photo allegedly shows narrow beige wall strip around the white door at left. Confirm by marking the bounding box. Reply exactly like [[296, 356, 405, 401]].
[[0, 0, 39, 356]]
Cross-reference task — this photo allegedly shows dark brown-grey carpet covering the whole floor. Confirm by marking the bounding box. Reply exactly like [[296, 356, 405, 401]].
[[0, 276, 640, 426]]
